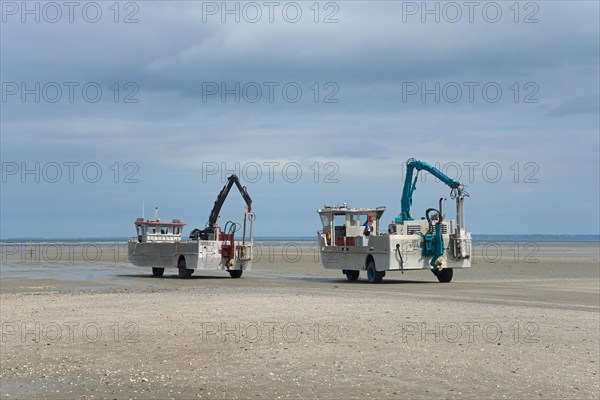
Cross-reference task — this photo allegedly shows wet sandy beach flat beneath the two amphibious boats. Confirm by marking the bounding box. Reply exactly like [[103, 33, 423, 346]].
[[0, 243, 600, 399]]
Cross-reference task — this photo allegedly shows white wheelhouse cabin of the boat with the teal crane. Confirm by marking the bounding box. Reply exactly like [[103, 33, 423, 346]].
[[318, 205, 385, 247]]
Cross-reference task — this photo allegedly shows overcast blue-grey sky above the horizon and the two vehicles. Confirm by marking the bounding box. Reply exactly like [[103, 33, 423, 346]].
[[0, 0, 600, 239]]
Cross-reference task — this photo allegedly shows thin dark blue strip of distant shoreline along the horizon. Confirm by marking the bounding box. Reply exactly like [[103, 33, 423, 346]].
[[0, 234, 600, 243]]
